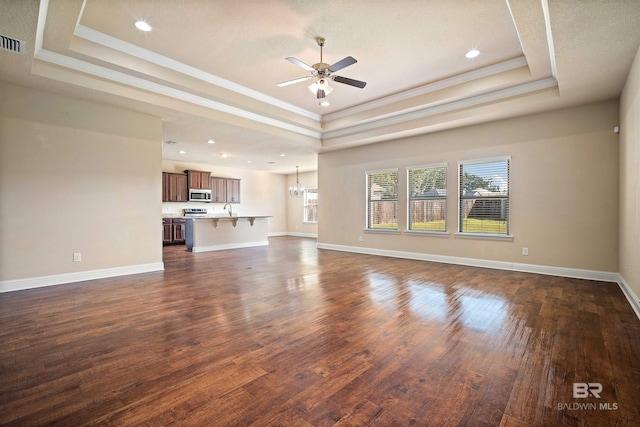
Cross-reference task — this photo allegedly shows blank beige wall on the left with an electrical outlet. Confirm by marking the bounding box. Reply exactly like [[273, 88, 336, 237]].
[[0, 84, 162, 291]]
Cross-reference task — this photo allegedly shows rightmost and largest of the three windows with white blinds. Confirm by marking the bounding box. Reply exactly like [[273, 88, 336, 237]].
[[458, 157, 511, 235]]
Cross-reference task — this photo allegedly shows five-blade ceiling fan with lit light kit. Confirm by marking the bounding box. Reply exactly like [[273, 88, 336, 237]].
[[276, 37, 367, 99]]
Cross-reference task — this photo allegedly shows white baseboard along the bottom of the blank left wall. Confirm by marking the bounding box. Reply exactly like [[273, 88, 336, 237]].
[[0, 262, 164, 293]]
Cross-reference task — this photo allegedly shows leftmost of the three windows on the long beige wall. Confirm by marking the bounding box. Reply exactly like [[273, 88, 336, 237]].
[[367, 169, 398, 230]]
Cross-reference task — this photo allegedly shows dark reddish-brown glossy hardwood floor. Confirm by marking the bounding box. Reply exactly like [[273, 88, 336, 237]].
[[0, 237, 640, 427]]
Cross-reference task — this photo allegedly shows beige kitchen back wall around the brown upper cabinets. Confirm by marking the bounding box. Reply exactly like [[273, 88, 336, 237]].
[[162, 160, 288, 234]]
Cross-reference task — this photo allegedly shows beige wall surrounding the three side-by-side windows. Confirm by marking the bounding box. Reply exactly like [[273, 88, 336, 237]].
[[318, 101, 618, 272]]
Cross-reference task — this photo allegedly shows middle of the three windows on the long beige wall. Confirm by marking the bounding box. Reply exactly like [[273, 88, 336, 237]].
[[407, 163, 447, 231]]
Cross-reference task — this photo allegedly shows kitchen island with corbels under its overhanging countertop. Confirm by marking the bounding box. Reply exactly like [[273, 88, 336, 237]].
[[185, 215, 270, 252]]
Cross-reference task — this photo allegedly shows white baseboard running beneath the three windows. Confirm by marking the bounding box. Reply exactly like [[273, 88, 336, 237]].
[[318, 243, 618, 283]]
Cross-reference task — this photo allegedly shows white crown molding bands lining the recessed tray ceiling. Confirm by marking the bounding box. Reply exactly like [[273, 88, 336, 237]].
[[34, 0, 558, 153]]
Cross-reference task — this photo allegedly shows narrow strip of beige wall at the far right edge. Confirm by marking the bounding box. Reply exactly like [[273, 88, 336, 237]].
[[618, 45, 640, 304]]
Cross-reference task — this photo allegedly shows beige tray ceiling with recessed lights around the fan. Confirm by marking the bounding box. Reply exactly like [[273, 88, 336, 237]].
[[0, 0, 640, 173]]
